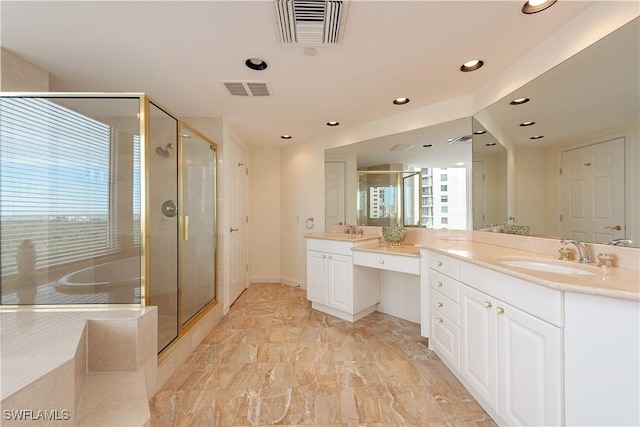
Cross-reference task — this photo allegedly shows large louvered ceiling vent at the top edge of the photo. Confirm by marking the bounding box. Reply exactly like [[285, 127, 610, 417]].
[[275, 0, 346, 45]]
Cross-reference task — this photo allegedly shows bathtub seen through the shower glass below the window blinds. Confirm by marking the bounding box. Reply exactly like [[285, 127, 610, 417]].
[[55, 257, 140, 304]]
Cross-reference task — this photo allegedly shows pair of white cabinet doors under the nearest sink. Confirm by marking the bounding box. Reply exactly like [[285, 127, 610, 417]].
[[460, 284, 562, 426]]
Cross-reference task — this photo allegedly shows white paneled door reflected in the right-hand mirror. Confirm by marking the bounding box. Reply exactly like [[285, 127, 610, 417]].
[[561, 138, 626, 243]]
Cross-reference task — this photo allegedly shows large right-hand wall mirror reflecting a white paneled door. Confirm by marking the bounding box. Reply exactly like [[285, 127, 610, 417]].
[[473, 18, 640, 247]]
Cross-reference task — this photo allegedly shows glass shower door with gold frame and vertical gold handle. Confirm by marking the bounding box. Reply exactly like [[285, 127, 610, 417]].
[[180, 125, 216, 326]]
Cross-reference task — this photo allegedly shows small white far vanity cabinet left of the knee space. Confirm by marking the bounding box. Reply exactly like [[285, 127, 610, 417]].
[[307, 238, 380, 322]]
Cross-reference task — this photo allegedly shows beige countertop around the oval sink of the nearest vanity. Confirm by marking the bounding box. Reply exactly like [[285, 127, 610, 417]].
[[416, 239, 640, 300]]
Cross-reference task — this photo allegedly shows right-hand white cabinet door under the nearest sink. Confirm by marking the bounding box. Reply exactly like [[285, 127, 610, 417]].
[[496, 301, 563, 426]]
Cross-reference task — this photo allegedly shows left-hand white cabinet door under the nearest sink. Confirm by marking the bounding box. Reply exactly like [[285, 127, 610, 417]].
[[459, 284, 498, 408]]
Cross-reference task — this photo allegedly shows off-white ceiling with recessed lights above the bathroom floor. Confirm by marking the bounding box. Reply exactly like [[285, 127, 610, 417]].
[[0, 0, 594, 146]]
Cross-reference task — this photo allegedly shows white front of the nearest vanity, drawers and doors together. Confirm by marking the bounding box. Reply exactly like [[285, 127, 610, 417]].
[[422, 251, 564, 426]]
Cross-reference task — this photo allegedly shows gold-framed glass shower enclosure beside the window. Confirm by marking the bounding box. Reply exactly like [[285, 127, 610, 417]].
[[0, 93, 217, 351]]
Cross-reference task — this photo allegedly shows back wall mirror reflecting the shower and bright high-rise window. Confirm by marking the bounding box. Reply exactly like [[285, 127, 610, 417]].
[[325, 117, 472, 229]]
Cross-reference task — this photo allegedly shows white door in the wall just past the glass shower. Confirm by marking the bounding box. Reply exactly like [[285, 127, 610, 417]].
[[225, 140, 249, 305]]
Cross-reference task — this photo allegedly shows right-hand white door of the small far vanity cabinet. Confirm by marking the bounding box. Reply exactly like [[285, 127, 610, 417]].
[[327, 254, 353, 313]]
